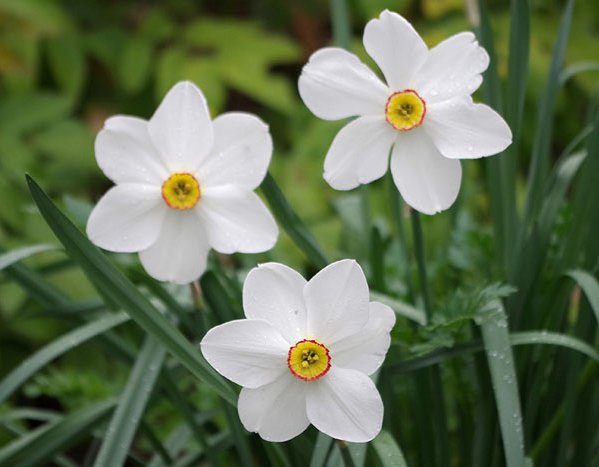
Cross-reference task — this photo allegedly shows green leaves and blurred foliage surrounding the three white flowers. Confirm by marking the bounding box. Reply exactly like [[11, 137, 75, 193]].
[[0, 0, 599, 467]]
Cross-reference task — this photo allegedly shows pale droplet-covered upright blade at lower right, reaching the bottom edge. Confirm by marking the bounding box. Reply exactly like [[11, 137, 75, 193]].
[[480, 301, 524, 467]]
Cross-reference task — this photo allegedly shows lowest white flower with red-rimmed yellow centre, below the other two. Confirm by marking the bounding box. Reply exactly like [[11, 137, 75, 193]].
[[201, 260, 395, 442]]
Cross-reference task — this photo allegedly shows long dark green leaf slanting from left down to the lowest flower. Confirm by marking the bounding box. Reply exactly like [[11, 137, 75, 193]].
[[27, 176, 237, 405]]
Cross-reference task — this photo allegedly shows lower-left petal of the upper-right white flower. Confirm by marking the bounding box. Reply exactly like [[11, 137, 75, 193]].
[[324, 116, 396, 190]]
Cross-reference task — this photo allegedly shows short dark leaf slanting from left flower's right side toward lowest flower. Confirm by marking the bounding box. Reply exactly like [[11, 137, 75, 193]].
[[260, 174, 329, 269]]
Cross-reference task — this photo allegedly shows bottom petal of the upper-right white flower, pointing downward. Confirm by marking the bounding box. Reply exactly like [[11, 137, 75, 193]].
[[391, 129, 462, 214]]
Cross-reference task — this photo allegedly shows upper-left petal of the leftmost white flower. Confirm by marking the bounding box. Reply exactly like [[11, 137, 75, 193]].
[[95, 116, 169, 185]]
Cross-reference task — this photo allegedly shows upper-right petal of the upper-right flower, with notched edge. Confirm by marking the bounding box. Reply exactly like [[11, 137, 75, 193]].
[[413, 32, 489, 105]]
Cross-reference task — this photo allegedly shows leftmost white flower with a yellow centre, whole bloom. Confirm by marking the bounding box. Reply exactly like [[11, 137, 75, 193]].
[[87, 82, 278, 283]]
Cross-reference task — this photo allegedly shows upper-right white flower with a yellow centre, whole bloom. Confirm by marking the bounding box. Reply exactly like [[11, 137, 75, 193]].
[[299, 11, 512, 214]]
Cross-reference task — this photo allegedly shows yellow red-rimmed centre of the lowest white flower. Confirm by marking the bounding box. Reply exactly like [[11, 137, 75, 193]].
[[287, 339, 331, 381]]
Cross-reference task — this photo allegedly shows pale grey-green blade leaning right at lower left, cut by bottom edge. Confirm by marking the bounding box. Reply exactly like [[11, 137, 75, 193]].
[[94, 336, 165, 467]]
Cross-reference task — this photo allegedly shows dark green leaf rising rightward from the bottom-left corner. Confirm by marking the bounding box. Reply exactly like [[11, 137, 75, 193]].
[[0, 399, 115, 467]]
